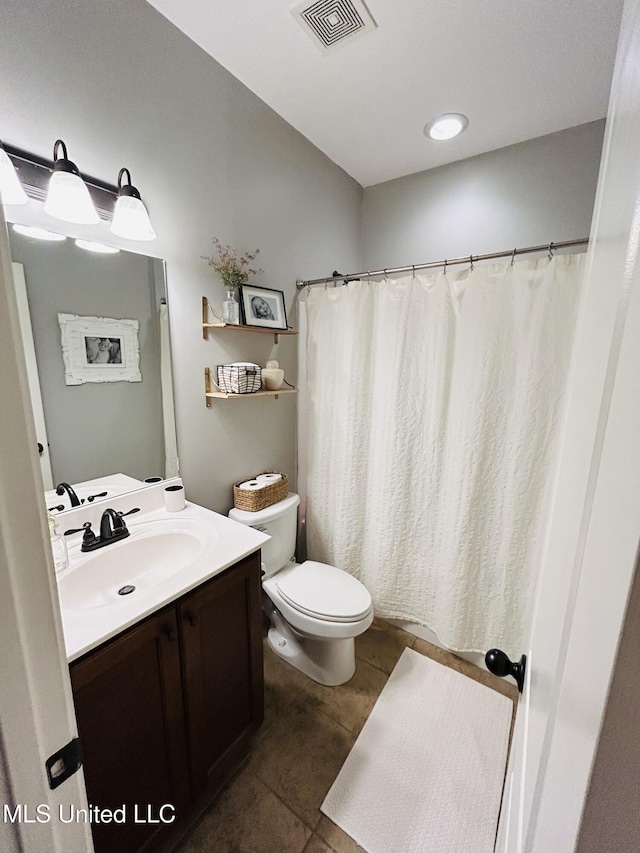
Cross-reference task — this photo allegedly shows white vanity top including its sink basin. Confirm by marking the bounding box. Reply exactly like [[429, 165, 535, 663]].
[[56, 496, 269, 663]]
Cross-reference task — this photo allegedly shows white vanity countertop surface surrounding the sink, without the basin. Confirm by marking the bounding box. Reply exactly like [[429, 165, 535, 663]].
[[56, 478, 269, 662]]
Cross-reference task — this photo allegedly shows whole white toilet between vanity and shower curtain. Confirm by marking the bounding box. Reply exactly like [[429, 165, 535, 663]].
[[229, 492, 373, 686]]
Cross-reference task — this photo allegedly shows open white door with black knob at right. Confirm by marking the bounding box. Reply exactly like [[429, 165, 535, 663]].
[[496, 0, 640, 853]]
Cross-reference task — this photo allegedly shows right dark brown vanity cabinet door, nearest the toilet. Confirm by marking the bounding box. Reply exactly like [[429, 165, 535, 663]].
[[178, 553, 264, 796]]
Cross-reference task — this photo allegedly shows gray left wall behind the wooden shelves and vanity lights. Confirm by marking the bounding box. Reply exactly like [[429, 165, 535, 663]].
[[0, 0, 362, 511]]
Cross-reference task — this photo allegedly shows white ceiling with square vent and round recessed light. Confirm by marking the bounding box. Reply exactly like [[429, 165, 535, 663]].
[[149, 0, 623, 186]]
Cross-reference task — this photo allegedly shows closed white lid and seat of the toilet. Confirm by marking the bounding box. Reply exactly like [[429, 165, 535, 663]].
[[275, 560, 371, 622]]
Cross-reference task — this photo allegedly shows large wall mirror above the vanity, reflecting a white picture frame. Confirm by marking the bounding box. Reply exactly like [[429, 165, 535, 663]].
[[8, 225, 178, 510]]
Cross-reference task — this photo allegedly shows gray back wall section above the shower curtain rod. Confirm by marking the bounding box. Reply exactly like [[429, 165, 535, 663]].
[[363, 121, 604, 269]]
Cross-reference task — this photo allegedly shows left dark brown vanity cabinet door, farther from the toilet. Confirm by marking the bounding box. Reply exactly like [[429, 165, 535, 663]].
[[71, 607, 191, 853]]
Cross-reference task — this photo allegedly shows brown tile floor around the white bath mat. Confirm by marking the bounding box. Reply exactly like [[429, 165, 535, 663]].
[[165, 619, 518, 853]]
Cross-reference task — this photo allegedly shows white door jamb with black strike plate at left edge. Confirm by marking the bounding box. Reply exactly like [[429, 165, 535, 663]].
[[0, 205, 93, 853]]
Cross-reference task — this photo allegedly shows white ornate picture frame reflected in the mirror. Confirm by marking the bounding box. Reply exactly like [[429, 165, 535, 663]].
[[58, 314, 142, 385]]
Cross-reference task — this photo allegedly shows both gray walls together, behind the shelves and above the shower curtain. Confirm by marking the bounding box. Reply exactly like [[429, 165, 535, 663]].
[[0, 0, 603, 511]]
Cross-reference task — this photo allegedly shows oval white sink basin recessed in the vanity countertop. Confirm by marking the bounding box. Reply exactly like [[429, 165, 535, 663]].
[[58, 519, 217, 611]]
